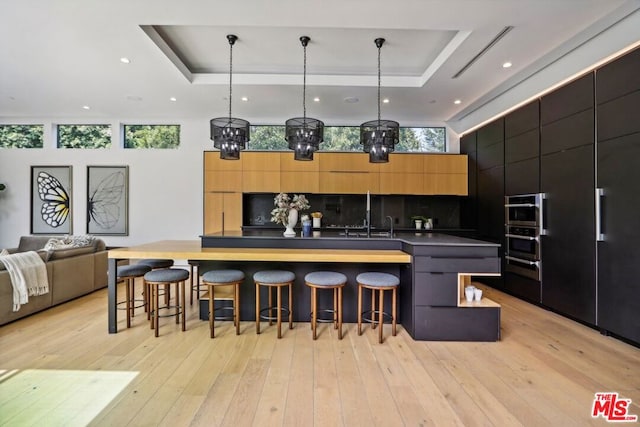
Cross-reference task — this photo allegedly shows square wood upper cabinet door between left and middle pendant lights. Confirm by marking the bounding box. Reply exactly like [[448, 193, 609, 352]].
[[240, 151, 280, 193]]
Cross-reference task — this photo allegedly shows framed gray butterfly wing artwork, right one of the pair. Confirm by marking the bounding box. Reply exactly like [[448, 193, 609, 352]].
[[87, 166, 129, 236]]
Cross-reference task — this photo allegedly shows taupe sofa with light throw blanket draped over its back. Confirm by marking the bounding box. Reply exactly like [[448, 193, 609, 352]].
[[0, 236, 107, 325]]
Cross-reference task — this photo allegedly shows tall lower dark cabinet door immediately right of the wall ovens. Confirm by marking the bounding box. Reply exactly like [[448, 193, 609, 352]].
[[540, 144, 596, 324]]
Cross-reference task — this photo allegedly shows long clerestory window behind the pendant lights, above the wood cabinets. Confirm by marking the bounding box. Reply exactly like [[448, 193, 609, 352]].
[[248, 126, 446, 153]]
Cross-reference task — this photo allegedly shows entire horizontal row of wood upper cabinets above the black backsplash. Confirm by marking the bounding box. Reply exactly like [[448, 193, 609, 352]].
[[204, 151, 468, 195]]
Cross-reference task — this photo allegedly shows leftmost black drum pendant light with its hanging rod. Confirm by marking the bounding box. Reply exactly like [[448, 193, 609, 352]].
[[210, 34, 250, 160]]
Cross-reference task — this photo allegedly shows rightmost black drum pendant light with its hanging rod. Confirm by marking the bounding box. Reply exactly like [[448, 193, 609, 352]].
[[360, 38, 400, 163]]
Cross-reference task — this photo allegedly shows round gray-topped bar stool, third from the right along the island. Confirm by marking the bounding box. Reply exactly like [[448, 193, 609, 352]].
[[253, 270, 296, 338]]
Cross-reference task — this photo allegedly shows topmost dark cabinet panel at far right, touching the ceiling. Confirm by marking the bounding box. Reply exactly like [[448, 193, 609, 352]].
[[596, 48, 640, 105]]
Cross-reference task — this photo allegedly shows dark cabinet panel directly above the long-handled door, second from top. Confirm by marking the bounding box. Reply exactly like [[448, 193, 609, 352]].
[[598, 90, 640, 142]]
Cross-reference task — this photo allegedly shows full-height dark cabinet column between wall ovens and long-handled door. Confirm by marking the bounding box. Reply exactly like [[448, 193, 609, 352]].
[[540, 73, 596, 324]]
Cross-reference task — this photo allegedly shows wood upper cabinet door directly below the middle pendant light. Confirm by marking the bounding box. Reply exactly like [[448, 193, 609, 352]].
[[280, 152, 320, 193]]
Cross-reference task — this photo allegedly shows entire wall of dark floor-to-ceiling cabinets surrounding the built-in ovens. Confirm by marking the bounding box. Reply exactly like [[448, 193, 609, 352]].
[[461, 49, 640, 344]]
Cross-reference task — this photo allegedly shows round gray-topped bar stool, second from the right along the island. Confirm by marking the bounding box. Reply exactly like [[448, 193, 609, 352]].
[[304, 271, 347, 340]]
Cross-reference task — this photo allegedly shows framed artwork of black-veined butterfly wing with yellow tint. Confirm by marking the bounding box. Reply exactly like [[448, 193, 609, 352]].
[[31, 166, 73, 234]]
